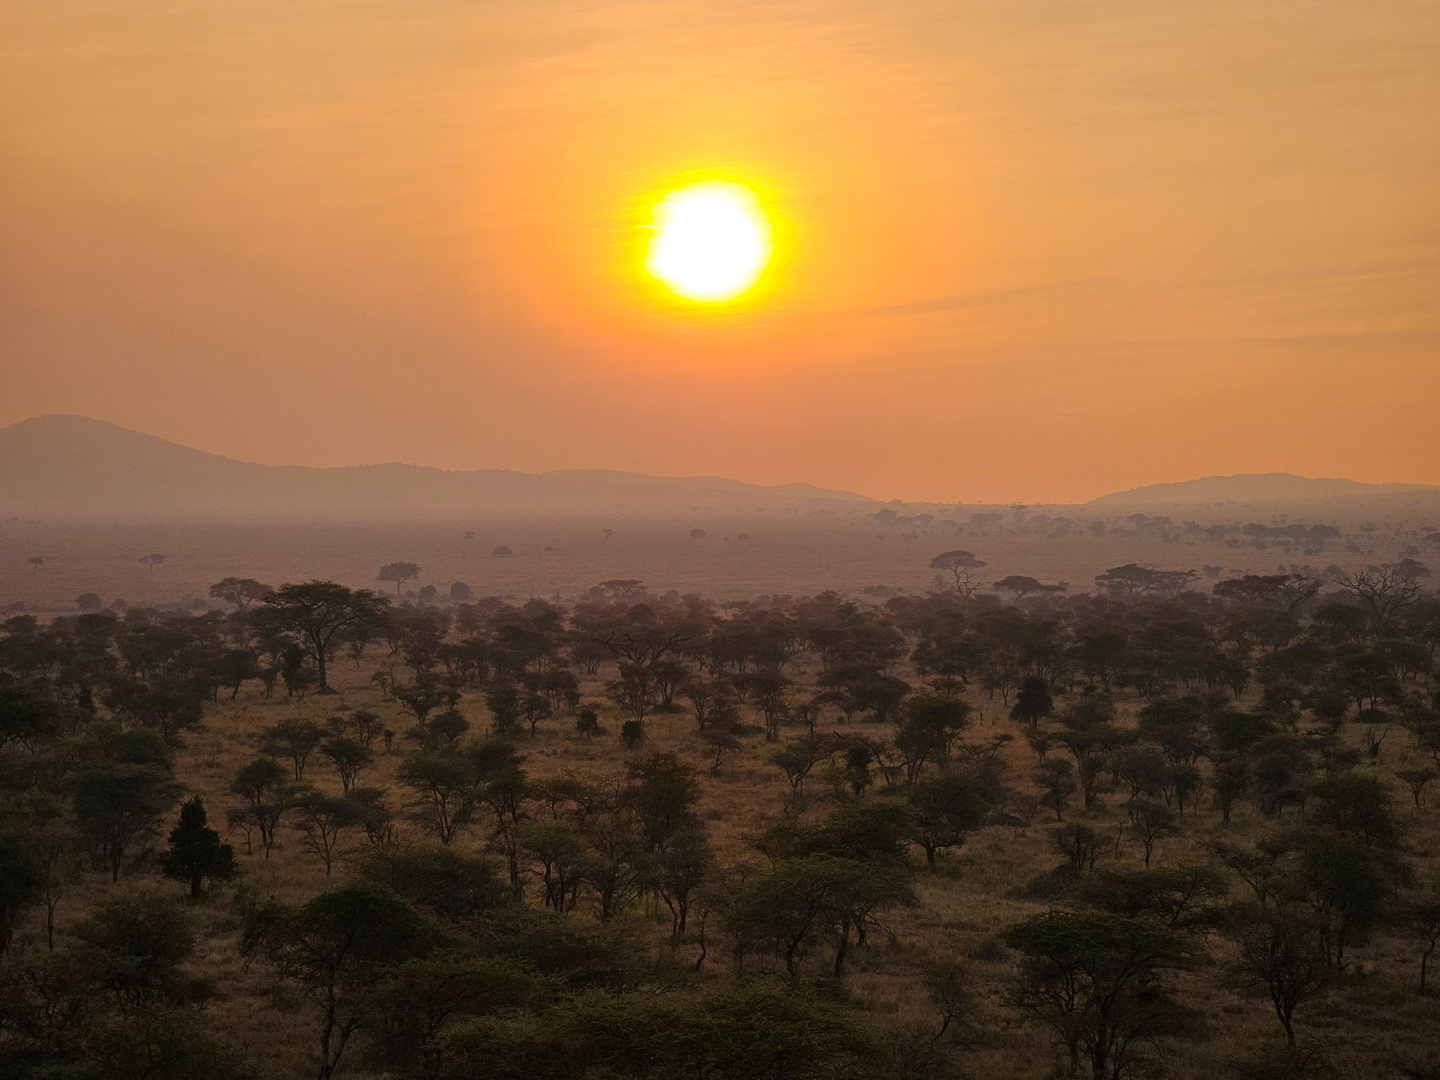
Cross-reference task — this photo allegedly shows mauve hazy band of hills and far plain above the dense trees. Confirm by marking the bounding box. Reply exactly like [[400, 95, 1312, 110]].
[[0, 416, 1440, 612]]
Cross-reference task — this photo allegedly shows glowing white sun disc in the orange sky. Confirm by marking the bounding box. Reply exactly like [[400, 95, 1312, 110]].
[[645, 181, 770, 304]]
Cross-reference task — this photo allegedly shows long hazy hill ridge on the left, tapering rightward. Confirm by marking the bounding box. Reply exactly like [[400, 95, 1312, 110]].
[[0, 416, 873, 520]]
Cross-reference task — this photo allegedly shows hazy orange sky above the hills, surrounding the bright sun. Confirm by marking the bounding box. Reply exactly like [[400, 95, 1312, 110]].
[[0, 0, 1440, 501]]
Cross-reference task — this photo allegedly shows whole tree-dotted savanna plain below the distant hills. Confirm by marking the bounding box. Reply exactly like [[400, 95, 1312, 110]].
[[0, 498, 1440, 1080]]
